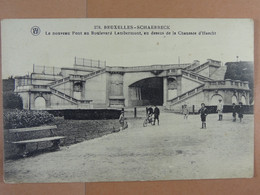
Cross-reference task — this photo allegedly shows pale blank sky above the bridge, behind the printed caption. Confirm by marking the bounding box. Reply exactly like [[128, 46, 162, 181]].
[[1, 19, 254, 78]]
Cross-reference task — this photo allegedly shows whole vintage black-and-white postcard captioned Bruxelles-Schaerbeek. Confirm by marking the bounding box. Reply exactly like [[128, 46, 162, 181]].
[[1, 19, 254, 183]]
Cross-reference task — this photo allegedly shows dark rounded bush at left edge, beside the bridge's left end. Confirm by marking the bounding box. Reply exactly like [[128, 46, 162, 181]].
[[3, 92, 23, 110]]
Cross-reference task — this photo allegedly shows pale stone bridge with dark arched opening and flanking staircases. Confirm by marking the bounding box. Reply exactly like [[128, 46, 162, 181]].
[[15, 58, 253, 111]]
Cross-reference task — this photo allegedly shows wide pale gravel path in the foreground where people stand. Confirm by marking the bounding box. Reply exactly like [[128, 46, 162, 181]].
[[4, 113, 254, 183]]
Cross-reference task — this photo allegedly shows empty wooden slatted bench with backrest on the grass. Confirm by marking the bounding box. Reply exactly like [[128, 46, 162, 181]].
[[8, 125, 65, 157]]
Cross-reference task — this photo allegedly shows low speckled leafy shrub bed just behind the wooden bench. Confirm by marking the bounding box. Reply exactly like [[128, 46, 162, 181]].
[[4, 109, 54, 129]]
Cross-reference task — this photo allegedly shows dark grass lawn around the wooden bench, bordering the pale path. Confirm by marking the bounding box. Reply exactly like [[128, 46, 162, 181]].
[[4, 117, 120, 159]]
